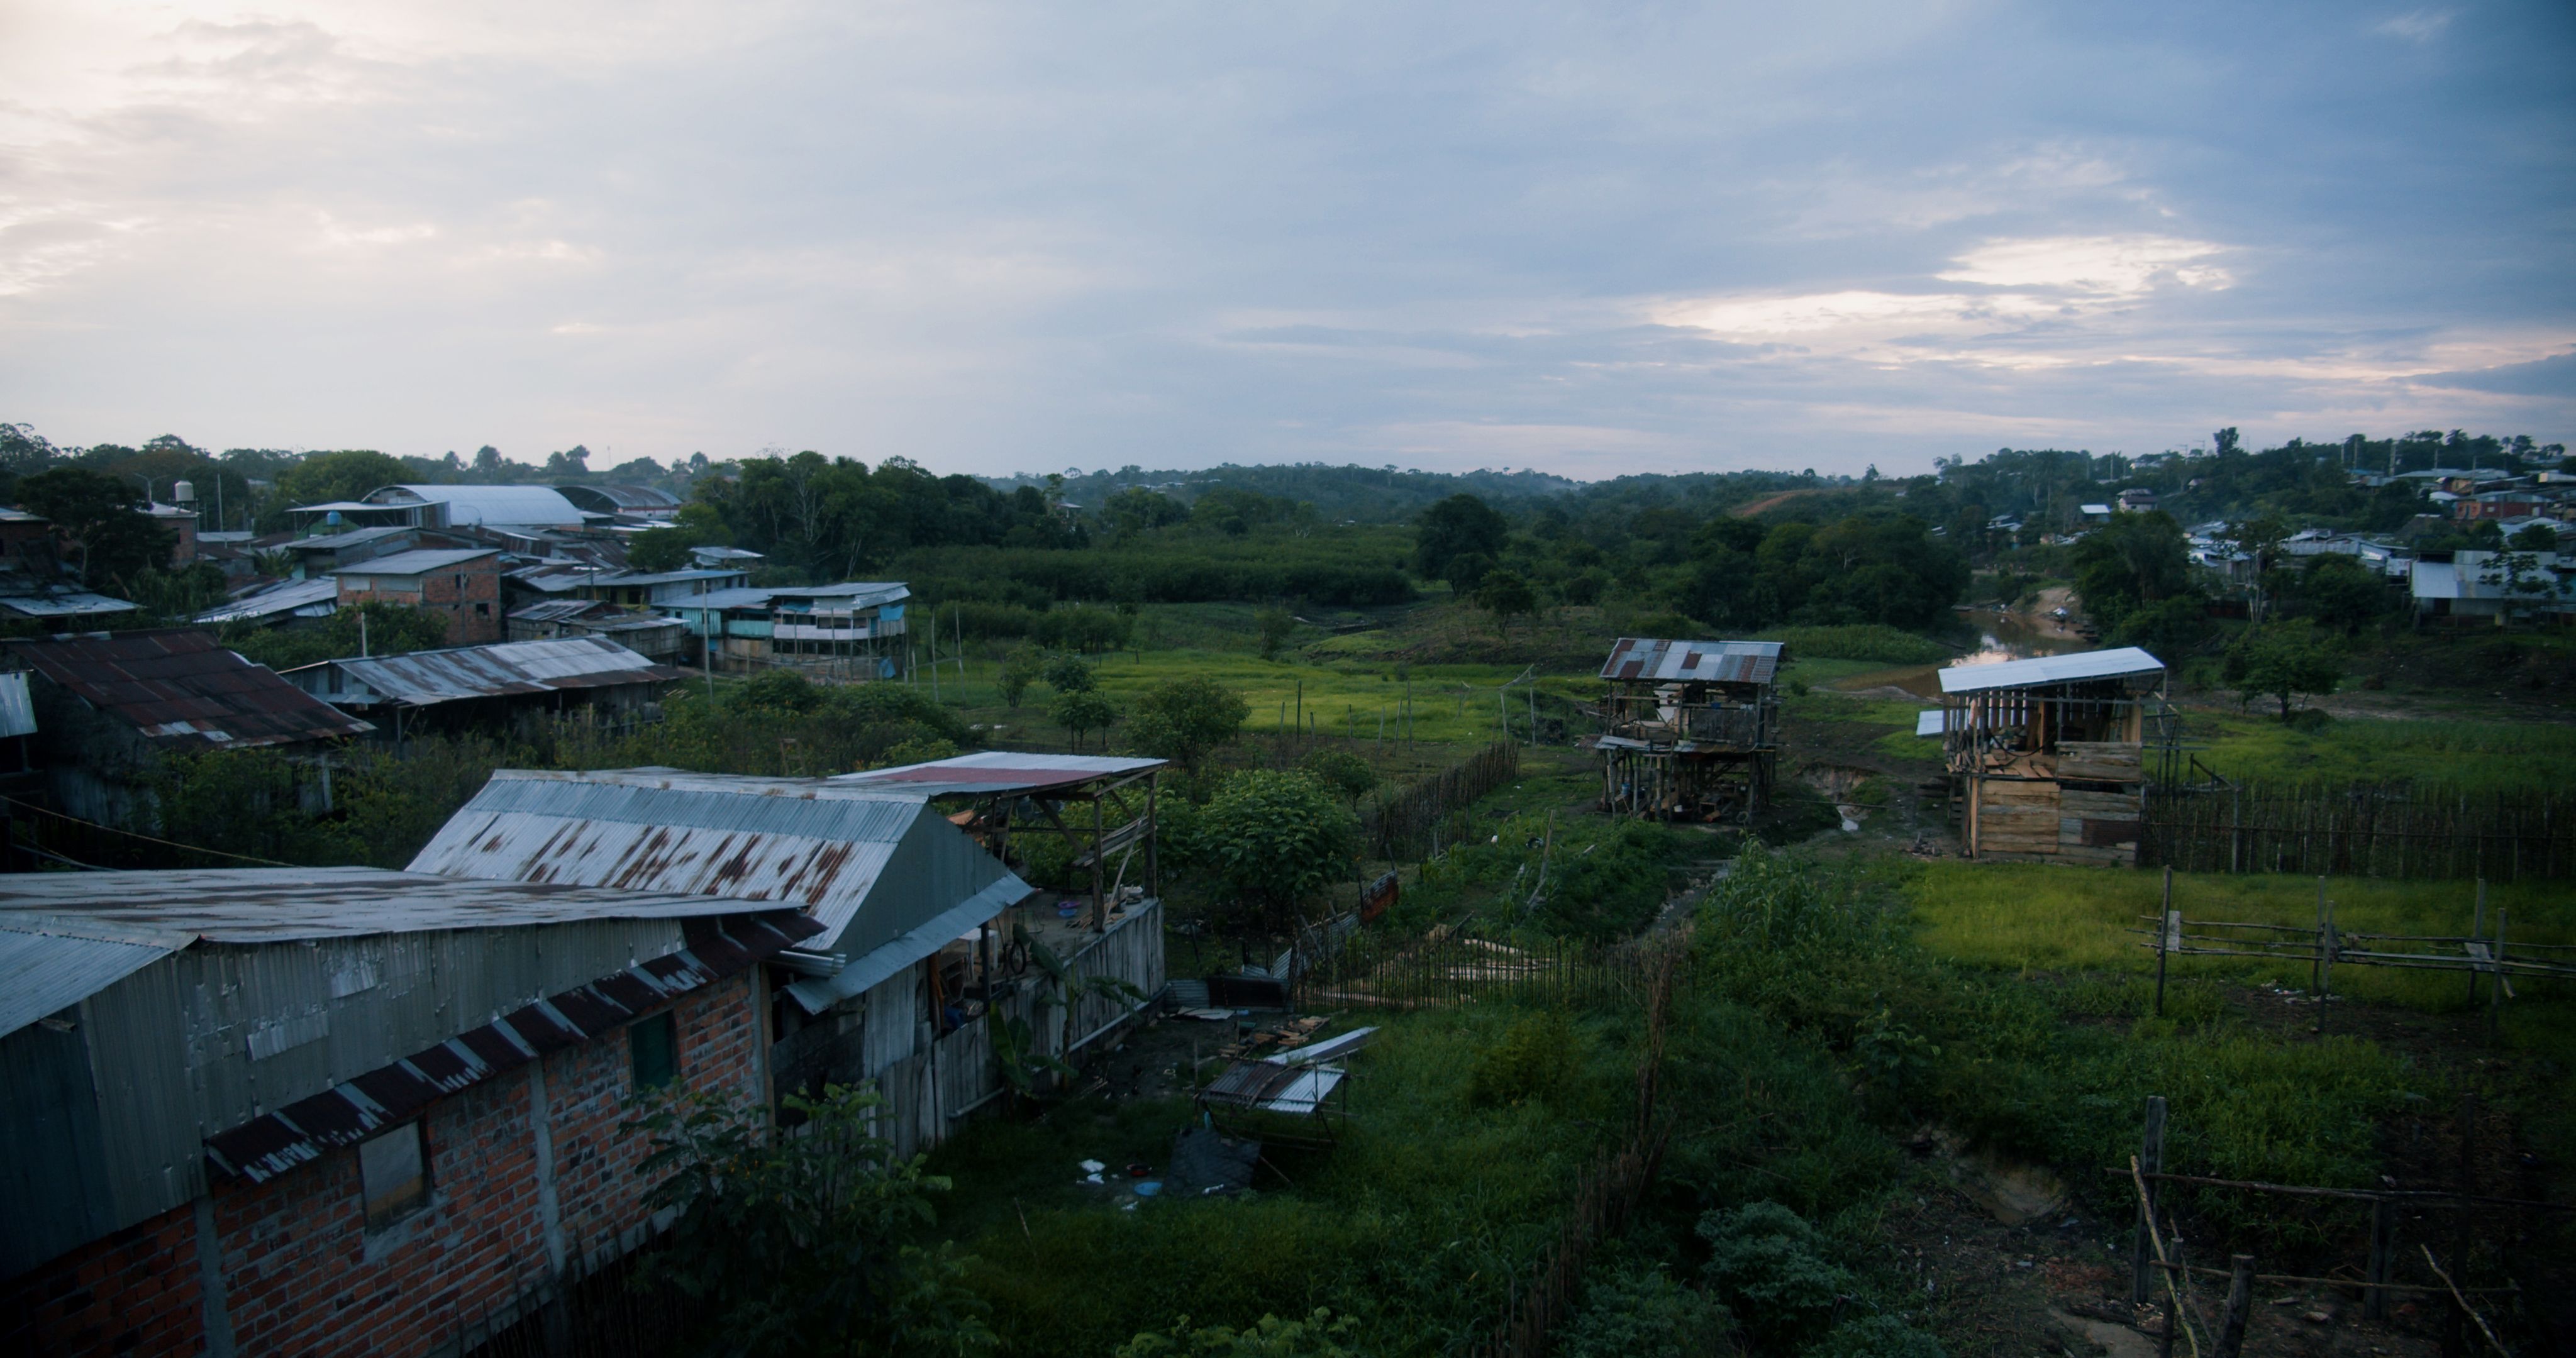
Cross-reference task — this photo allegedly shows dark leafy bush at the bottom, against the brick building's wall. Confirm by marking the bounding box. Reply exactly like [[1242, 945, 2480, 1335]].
[[618, 1085, 997, 1358]]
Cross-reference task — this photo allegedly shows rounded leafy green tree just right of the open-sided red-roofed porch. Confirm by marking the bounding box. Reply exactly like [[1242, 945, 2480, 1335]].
[[1192, 768, 1360, 928]]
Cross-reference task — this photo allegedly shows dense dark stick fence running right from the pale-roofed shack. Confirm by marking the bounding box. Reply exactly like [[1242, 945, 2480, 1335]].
[[2138, 783, 2576, 881]]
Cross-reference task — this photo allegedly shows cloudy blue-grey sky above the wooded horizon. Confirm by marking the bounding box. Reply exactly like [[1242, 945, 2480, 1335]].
[[0, 0, 2576, 479]]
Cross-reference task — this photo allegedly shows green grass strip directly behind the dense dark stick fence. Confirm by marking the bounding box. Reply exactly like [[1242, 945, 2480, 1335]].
[[2182, 709, 2576, 793]]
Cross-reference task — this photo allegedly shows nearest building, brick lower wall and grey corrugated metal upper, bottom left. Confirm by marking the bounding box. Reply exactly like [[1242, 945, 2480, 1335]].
[[0, 868, 819, 1358]]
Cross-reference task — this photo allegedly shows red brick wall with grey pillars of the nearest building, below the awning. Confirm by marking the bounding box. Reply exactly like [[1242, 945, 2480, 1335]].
[[0, 974, 762, 1358]]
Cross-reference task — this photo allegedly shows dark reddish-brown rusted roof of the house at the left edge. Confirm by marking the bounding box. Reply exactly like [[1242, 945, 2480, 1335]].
[[5, 626, 376, 750]]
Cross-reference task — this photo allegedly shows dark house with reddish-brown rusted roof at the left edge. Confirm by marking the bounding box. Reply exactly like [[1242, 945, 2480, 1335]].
[[0, 626, 371, 825]]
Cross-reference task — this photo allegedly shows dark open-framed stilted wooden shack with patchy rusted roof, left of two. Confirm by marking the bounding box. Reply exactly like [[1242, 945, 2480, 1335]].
[[1594, 636, 1782, 822]]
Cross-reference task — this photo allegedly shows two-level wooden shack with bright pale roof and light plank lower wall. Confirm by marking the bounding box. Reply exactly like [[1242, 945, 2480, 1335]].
[[1916, 647, 2172, 863]]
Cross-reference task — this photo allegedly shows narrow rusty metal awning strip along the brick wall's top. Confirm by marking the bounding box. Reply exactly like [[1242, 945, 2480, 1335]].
[[206, 910, 822, 1183]]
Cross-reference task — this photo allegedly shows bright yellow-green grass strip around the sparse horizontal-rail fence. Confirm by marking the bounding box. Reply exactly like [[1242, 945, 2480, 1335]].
[[1906, 863, 2576, 1025]]
